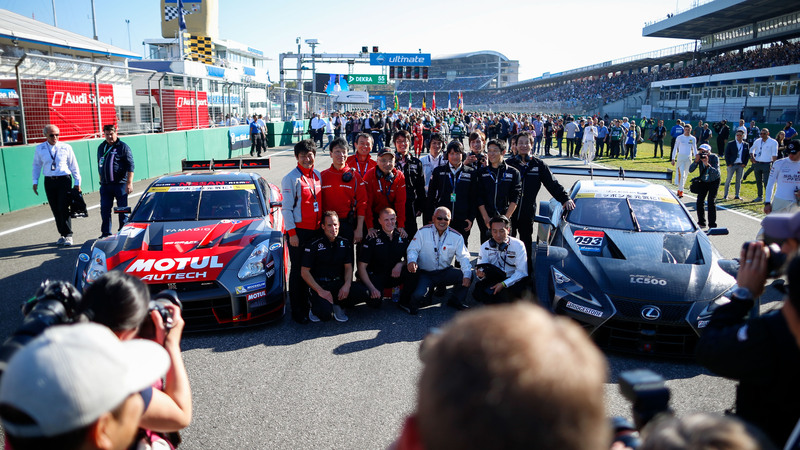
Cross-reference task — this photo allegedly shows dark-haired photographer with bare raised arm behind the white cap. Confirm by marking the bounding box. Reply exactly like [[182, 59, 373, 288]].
[[79, 270, 192, 448]]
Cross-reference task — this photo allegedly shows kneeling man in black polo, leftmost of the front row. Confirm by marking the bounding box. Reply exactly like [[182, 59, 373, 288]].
[[300, 211, 353, 322]]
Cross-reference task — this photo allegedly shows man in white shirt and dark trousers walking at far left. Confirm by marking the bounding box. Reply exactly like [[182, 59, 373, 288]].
[[33, 125, 81, 247]]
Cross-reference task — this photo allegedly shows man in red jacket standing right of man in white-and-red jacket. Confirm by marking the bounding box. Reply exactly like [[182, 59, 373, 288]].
[[319, 137, 367, 244]]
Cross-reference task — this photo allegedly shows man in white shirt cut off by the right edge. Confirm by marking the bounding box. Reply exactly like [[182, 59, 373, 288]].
[[764, 139, 800, 214]]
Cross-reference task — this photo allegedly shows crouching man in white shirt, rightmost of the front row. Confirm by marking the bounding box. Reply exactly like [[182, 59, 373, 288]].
[[472, 216, 528, 304]]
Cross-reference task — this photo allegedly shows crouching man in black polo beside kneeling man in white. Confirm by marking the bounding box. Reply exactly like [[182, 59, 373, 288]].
[[351, 208, 411, 308]]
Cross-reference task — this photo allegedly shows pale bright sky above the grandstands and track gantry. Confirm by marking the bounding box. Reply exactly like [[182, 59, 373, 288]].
[[0, 0, 707, 81]]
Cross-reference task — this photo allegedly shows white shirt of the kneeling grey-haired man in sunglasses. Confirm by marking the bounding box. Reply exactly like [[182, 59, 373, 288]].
[[406, 225, 472, 278]]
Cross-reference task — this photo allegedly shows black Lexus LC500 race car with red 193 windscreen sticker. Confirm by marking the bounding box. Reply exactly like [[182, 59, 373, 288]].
[[534, 180, 738, 356]]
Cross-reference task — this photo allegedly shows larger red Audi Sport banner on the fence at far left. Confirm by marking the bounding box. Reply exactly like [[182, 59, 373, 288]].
[[0, 80, 117, 143]]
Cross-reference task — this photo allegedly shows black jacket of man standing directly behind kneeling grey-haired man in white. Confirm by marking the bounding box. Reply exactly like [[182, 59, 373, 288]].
[[425, 163, 478, 223]]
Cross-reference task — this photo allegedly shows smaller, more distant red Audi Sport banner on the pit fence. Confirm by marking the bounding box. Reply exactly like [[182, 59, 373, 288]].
[[150, 89, 208, 131]]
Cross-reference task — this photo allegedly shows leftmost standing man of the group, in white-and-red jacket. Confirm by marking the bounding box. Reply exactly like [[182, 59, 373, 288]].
[[281, 139, 322, 323]]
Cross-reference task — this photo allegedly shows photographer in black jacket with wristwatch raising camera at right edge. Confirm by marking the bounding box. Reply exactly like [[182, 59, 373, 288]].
[[696, 214, 800, 446]]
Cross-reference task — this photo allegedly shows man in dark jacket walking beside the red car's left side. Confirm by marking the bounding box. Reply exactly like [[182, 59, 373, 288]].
[[97, 124, 134, 239]]
